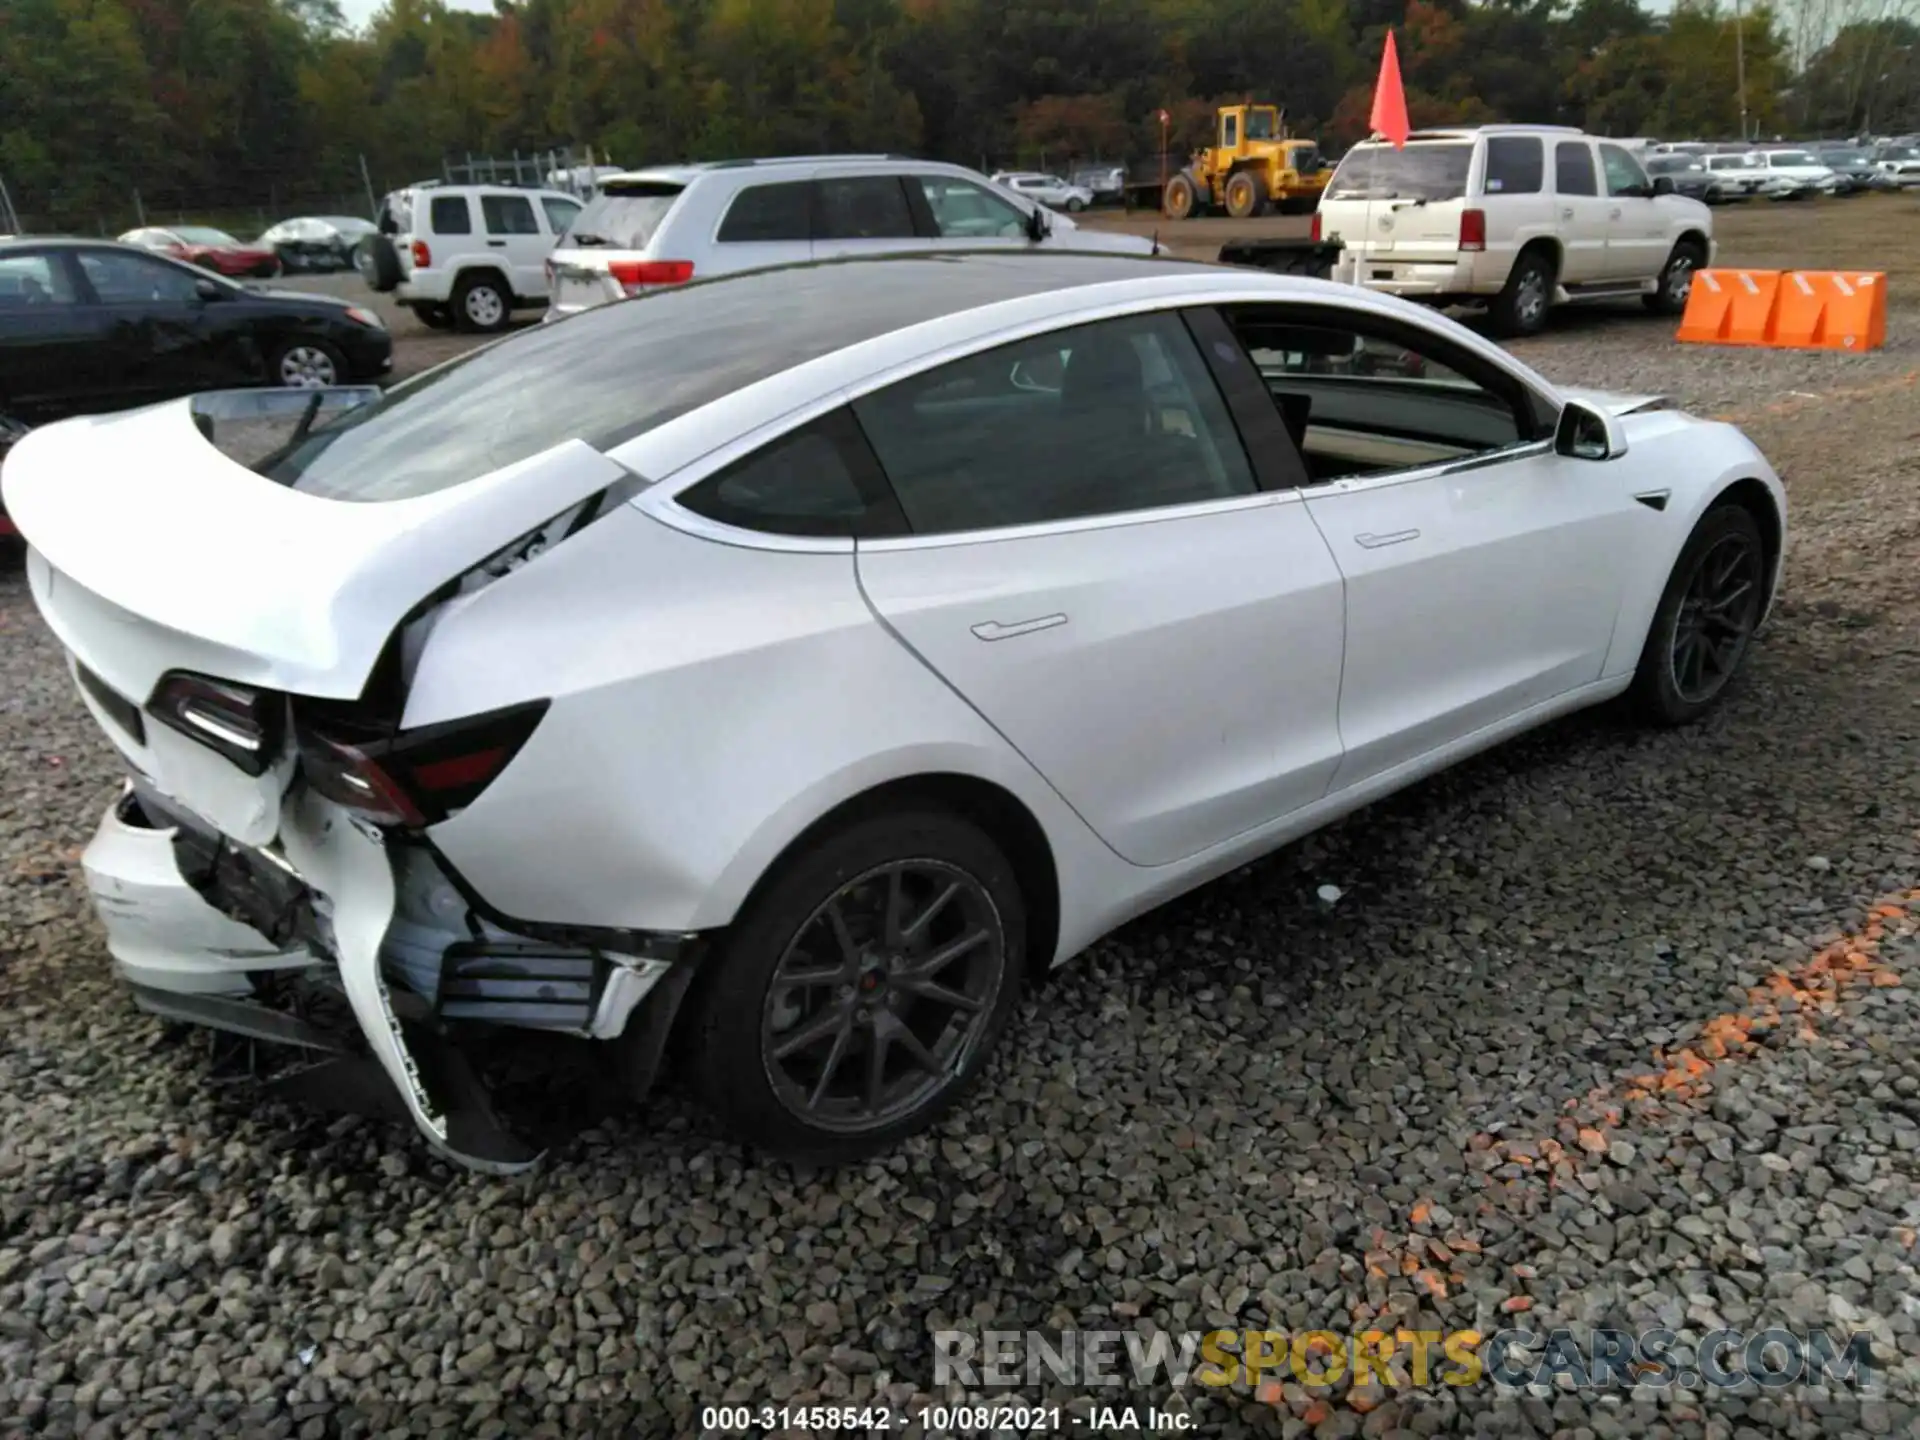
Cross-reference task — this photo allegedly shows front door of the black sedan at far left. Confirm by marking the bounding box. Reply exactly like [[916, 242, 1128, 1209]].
[[75, 248, 236, 403]]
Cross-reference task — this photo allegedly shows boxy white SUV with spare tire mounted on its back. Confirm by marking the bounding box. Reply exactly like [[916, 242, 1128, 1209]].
[[355, 184, 582, 330]]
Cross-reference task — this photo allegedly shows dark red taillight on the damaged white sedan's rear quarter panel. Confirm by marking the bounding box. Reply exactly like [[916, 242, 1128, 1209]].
[[294, 701, 547, 829]]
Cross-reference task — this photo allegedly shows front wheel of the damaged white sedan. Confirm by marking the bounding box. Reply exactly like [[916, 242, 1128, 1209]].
[[1632, 503, 1766, 726]]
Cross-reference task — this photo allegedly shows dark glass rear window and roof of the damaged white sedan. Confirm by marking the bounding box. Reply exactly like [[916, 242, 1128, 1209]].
[[241, 255, 1175, 501]]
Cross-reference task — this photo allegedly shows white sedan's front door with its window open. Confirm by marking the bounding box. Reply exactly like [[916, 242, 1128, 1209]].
[[1231, 305, 1659, 789]]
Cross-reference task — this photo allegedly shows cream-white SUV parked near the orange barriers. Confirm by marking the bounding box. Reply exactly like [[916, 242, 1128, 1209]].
[[1313, 125, 1713, 334]]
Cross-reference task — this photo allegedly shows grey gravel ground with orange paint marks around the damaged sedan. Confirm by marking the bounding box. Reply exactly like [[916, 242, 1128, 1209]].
[[0, 202, 1920, 1438]]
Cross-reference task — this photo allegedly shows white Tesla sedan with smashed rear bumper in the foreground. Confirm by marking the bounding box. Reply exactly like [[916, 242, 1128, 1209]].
[[6, 253, 1786, 1169]]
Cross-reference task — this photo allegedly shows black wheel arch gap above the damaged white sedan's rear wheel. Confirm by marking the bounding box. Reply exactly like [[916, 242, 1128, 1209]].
[[714, 770, 1060, 977]]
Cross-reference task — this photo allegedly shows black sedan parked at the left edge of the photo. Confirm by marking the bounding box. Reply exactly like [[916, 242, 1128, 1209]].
[[0, 240, 394, 424]]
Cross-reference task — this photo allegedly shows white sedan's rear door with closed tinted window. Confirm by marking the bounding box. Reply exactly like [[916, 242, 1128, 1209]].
[[852, 311, 1342, 866]]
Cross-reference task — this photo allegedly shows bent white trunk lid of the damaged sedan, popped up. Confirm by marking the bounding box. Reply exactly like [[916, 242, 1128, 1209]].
[[4, 392, 632, 845]]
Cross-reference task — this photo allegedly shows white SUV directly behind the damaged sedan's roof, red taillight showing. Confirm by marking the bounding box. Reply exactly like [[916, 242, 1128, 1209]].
[[547, 156, 1160, 321]]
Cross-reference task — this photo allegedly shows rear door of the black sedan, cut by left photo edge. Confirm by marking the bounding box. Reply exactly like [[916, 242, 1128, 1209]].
[[0, 250, 109, 417]]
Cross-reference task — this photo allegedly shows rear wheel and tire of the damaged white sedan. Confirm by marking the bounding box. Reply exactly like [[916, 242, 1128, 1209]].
[[691, 812, 1025, 1162]]
